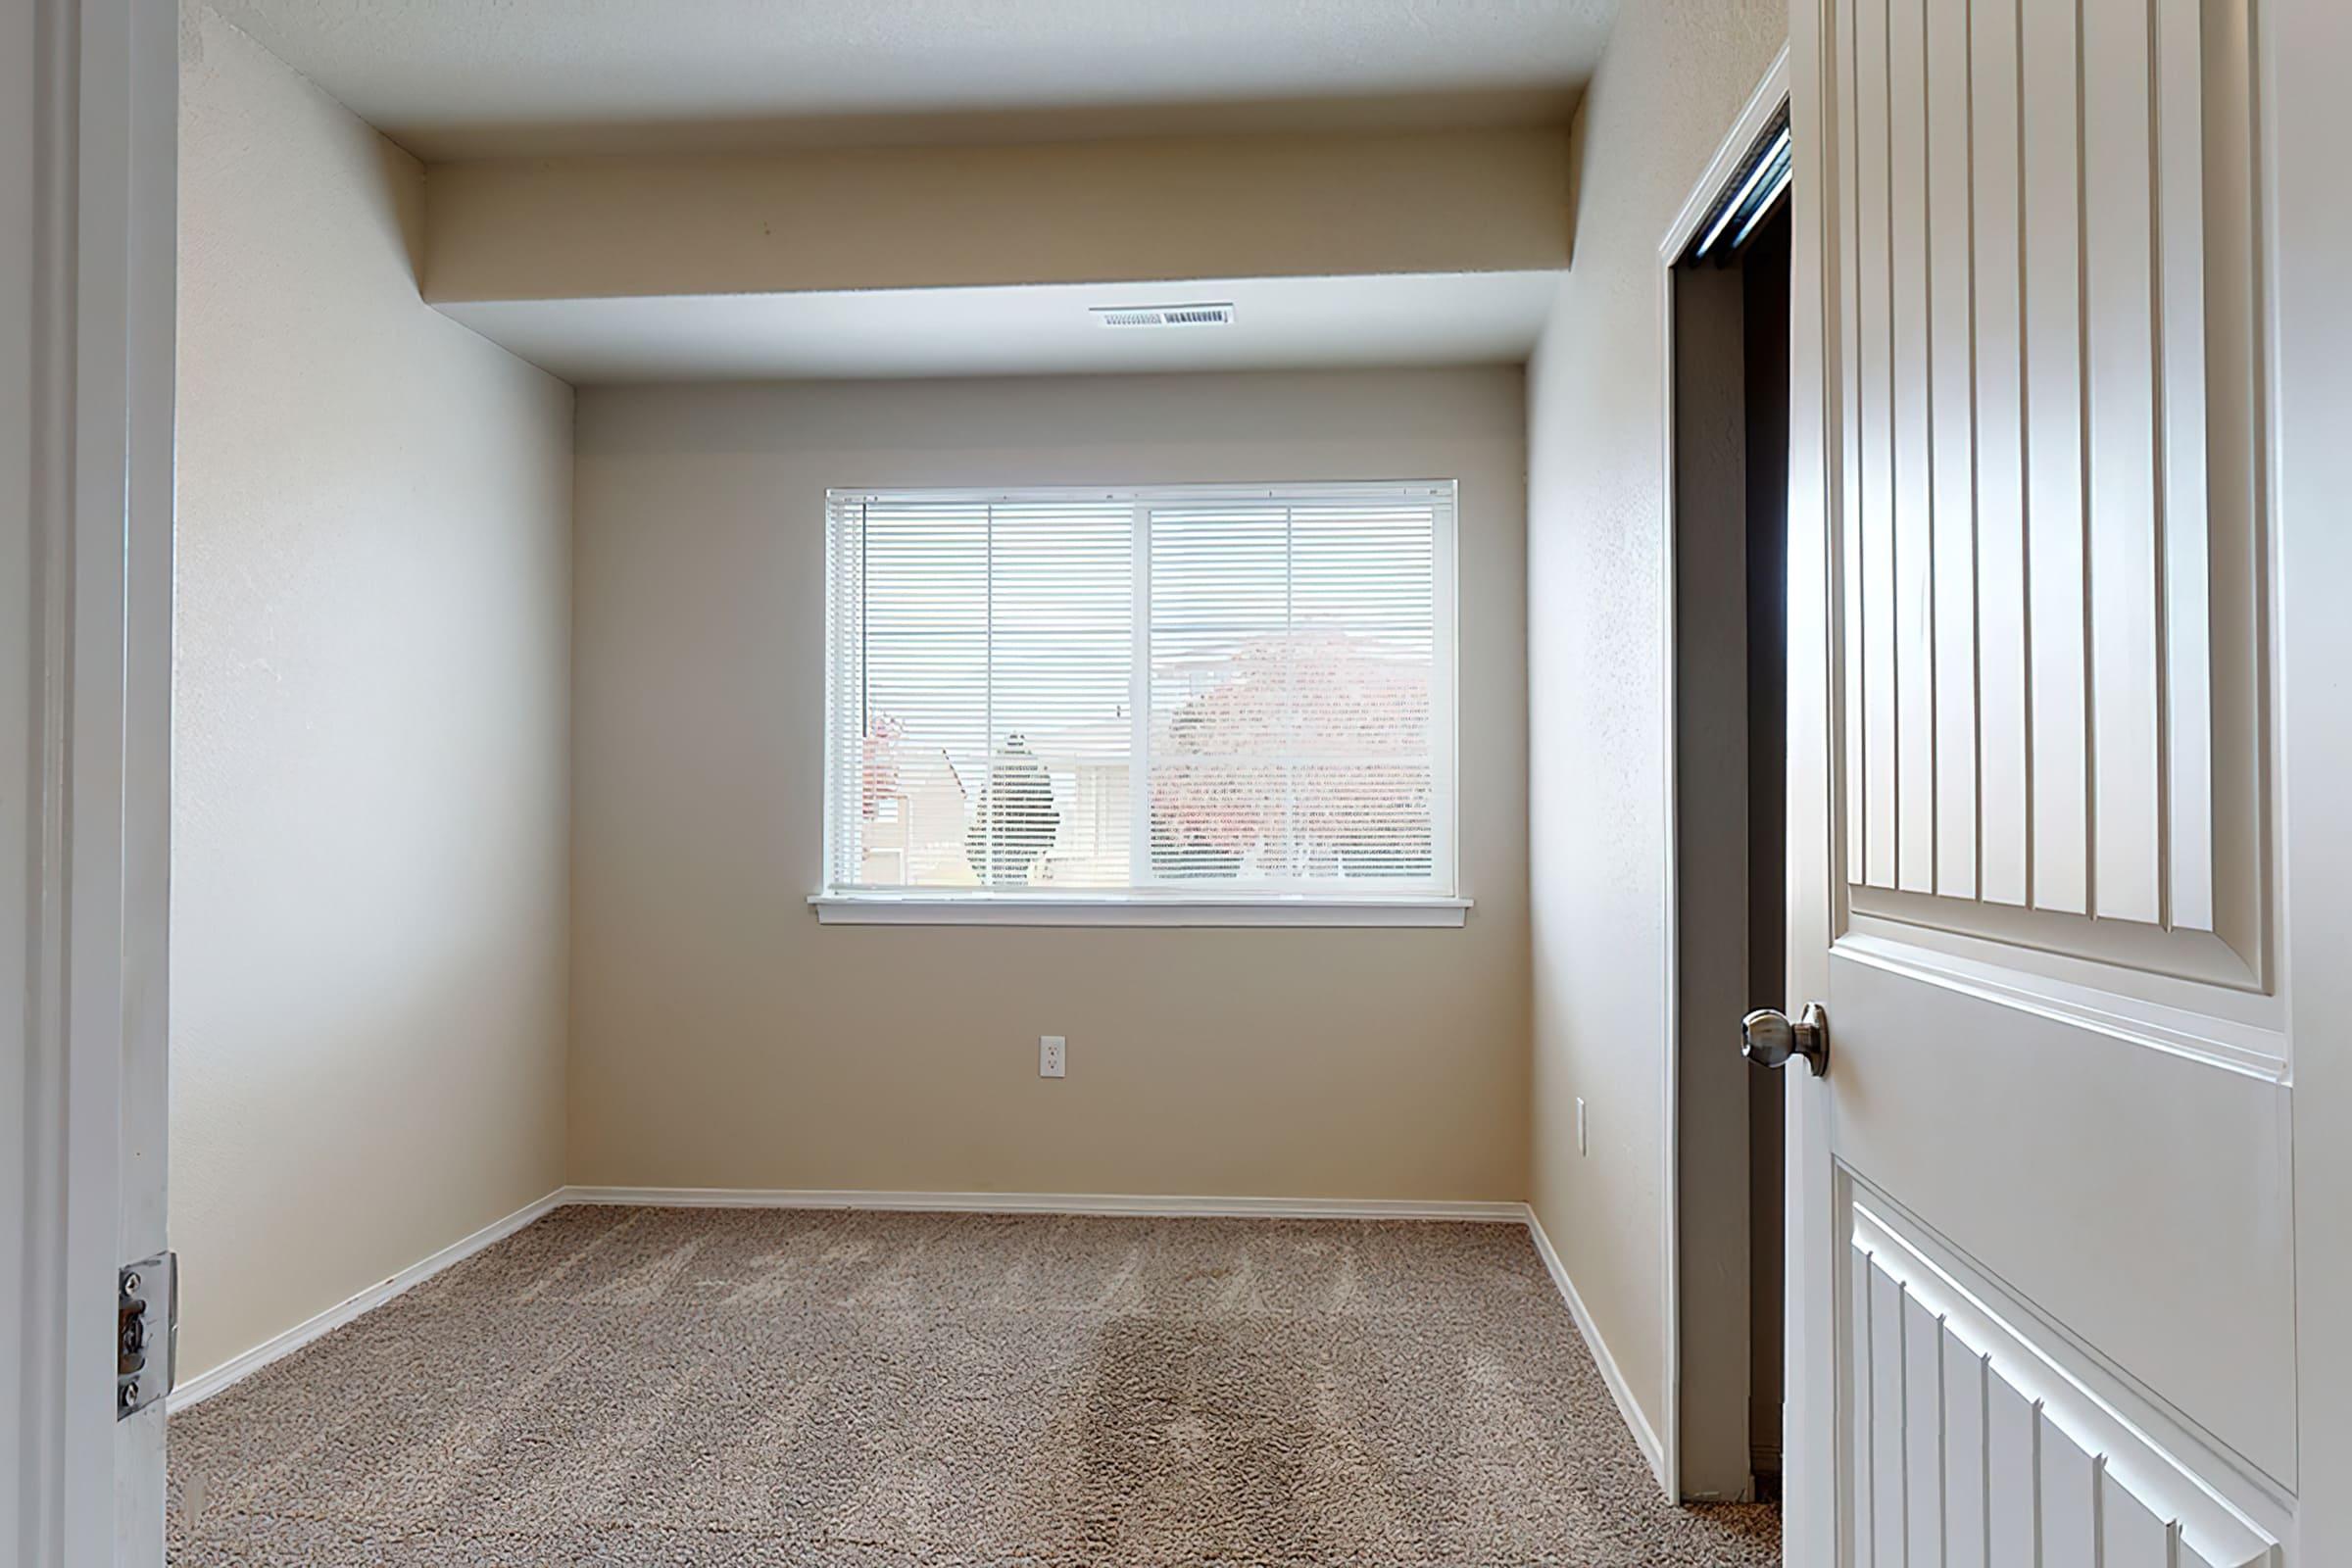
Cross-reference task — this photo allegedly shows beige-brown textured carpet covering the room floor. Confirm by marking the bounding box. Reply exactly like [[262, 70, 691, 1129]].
[[170, 1208, 1781, 1568]]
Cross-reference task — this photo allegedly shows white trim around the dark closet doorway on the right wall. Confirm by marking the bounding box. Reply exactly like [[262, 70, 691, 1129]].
[[1656, 45, 1801, 1504]]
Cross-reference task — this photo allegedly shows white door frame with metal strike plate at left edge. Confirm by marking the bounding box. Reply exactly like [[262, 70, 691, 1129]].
[[0, 0, 178, 1568]]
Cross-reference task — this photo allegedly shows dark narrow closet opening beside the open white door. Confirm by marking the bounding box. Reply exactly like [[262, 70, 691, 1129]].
[[1672, 127, 1789, 1497]]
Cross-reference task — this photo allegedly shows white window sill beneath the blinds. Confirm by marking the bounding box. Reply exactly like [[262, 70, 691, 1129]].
[[809, 894, 1470, 926]]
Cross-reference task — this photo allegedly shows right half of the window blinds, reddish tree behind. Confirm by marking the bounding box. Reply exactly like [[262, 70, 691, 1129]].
[[1146, 491, 1445, 891]]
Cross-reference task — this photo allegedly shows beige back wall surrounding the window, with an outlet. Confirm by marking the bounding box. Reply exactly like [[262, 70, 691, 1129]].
[[571, 369, 1527, 1199]]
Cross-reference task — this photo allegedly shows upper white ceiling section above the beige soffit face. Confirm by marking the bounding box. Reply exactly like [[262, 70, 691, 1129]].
[[212, 0, 1618, 160]]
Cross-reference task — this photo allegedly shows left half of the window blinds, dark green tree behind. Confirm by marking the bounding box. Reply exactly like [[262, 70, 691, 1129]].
[[833, 496, 1134, 889]]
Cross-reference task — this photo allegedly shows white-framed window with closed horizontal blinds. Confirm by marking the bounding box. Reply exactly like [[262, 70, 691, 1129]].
[[816, 484, 1460, 924]]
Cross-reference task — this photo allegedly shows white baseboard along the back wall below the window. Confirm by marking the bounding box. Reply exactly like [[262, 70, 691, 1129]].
[[558, 1187, 1527, 1225]]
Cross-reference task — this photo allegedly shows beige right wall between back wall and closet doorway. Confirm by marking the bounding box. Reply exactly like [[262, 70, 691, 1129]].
[[1527, 0, 1788, 1457]]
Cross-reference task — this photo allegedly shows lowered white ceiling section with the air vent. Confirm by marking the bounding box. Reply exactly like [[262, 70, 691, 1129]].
[[437, 272, 1559, 383]]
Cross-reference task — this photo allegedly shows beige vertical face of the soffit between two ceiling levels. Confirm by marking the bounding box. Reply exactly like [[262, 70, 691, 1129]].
[[425, 127, 1569, 301]]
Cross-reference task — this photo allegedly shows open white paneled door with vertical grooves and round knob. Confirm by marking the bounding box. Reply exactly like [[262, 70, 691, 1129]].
[[1789, 0, 2298, 1568]]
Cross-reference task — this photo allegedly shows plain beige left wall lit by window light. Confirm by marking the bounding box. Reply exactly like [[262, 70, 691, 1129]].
[[172, 12, 571, 1375]]
